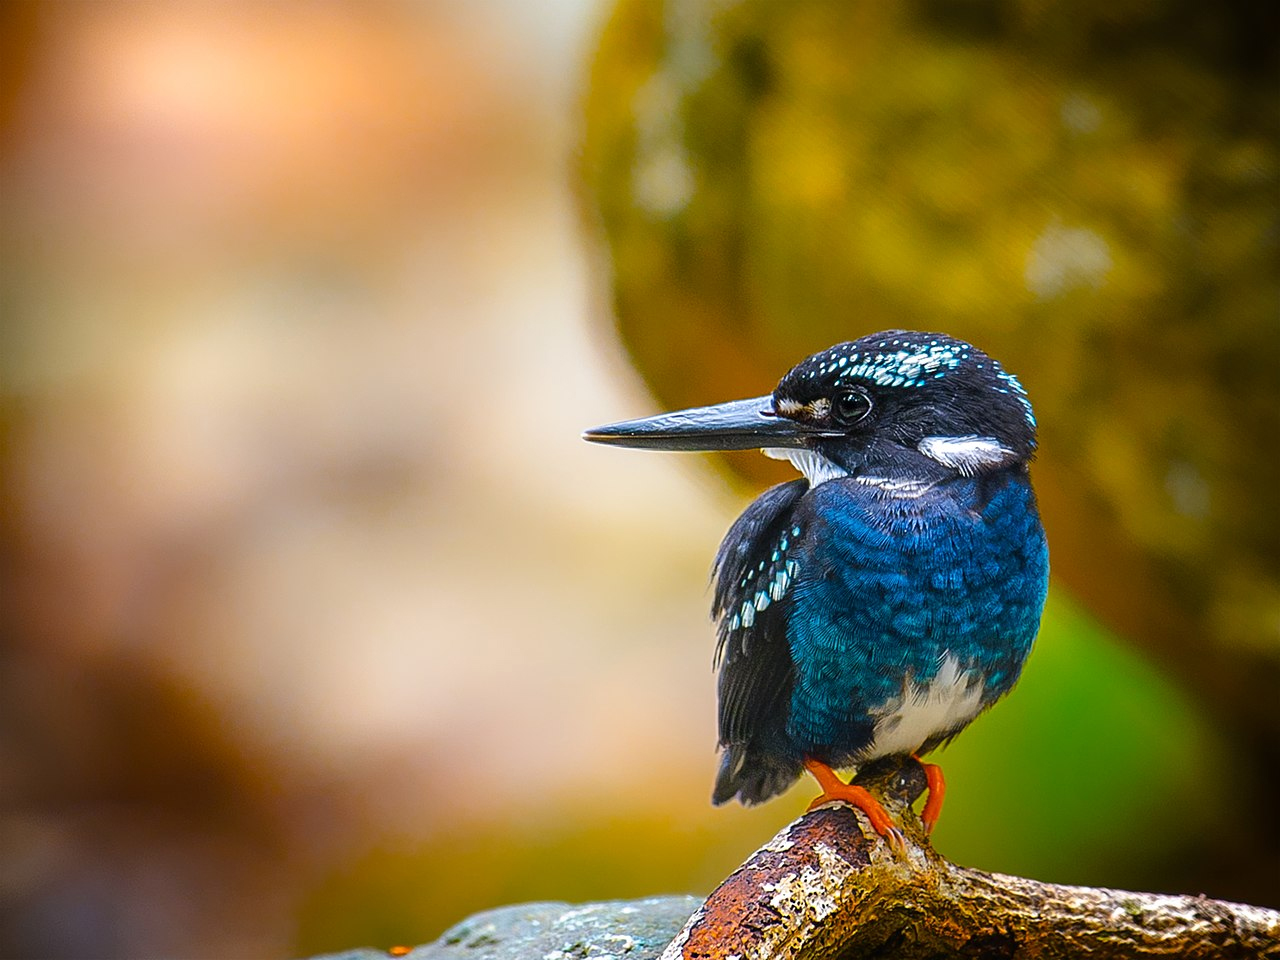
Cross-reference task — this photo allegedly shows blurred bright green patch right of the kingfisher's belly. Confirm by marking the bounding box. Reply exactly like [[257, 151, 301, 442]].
[[934, 589, 1226, 888]]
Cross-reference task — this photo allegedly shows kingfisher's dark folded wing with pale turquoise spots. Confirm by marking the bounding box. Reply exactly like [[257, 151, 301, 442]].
[[712, 479, 809, 804]]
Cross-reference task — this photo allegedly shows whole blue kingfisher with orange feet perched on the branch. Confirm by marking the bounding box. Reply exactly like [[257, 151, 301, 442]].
[[584, 330, 1048, 845]]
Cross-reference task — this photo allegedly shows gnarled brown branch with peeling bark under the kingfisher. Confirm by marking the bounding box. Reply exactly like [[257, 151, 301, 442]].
[[662, 762, 1280, 960]]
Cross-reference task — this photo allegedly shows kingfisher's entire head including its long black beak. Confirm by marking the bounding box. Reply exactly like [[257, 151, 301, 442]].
[[584, 330, 1036, 485]]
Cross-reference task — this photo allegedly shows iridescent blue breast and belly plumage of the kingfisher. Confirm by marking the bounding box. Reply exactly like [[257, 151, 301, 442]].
[[786, 474, 1048, 767]]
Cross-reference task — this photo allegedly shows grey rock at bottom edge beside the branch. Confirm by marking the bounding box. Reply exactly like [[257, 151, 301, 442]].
[[312, 896, 701, 960]]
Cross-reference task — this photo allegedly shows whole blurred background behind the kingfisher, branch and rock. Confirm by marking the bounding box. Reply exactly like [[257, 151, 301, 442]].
[[0, 0, 1280, 957]]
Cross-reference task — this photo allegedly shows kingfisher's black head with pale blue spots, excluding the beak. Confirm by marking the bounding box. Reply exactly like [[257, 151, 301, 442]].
[[773, 330, 1036, 483]]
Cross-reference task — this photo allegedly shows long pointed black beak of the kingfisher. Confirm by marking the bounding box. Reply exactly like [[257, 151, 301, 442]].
[[582, 396, 837, 451]]
